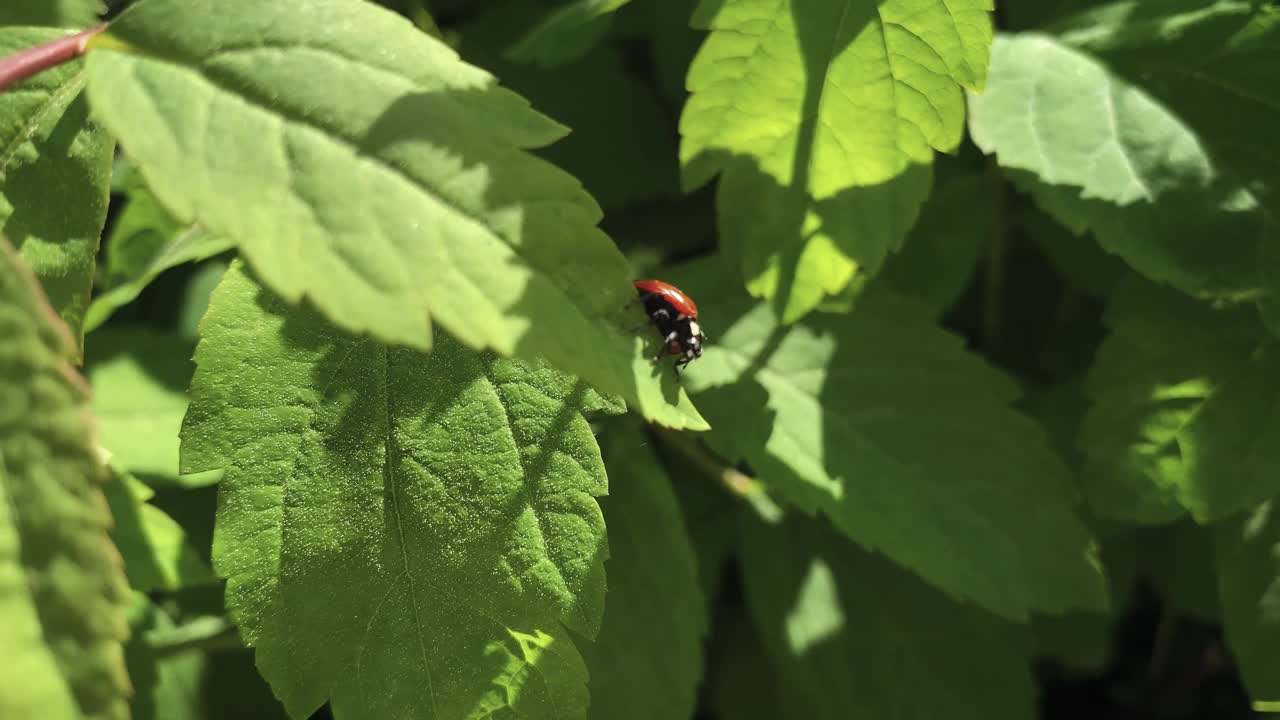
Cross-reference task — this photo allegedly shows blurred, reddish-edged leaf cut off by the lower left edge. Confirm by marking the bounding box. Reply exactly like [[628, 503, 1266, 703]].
[[0, 237, 129, 720]]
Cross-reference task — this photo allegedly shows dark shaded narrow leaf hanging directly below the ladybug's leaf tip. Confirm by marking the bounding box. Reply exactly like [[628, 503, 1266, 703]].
[[582, 428, 707, 720]]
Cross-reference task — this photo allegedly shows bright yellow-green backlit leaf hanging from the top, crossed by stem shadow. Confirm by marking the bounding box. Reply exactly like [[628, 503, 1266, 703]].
[[680, 0, 992, 323]]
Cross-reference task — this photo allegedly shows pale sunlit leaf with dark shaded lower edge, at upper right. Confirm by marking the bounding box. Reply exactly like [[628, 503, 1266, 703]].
[[969, 35, 1274, 297]]
